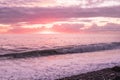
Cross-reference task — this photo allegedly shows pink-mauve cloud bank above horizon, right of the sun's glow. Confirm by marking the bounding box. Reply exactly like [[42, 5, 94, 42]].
[[52, 23, 120, 33]]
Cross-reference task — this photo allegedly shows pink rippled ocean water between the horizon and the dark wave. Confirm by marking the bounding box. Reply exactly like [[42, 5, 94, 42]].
[[0, 34, 120, 55]]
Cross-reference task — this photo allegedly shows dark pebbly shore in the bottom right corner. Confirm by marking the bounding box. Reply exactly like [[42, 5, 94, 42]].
[[58, 66, 120, 80]]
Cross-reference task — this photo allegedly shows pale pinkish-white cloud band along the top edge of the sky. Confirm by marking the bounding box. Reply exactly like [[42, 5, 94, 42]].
[[0, 0, 120, 8]]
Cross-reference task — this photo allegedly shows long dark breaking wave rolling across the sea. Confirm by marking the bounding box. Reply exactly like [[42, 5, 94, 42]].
[[0, 42, 120, 58]]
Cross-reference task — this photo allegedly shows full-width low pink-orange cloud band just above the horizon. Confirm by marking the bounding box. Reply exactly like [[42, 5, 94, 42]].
[[0, 23, 120, 34]]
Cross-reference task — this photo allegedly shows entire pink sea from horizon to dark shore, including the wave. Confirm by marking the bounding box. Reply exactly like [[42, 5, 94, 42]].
[[0, 34, 120, 80]]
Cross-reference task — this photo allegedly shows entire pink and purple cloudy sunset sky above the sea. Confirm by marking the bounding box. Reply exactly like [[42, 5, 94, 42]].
[[0, 0, 120, 34]]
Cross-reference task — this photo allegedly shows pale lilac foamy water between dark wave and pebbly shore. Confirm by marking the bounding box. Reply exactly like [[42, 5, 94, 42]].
[[0, 49, 120, 80]]
